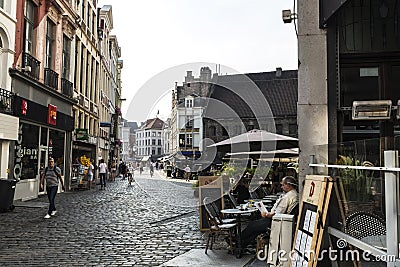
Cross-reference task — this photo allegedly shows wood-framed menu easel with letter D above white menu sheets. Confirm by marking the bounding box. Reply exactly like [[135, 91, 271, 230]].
[[291, 175, 333, 267]]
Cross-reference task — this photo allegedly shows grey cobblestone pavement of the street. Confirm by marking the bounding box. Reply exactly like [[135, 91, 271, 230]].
[[0, 174, 211, 266]]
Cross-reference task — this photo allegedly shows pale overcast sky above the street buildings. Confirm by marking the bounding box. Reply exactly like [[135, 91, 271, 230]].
[[99, 0, 297, 121]]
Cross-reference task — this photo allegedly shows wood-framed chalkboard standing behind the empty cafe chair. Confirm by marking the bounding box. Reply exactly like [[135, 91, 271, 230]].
[[198, 176, 224, 231]]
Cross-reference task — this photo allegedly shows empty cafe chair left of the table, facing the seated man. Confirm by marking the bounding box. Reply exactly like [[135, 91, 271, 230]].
[[203, 197, 236, 254]]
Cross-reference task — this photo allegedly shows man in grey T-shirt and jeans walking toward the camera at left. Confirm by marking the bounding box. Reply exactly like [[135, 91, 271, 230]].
[[40, 157, 65, 219]]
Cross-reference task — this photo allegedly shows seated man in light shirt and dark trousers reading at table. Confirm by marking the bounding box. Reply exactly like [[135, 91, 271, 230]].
[[242, 176, 299, 248]]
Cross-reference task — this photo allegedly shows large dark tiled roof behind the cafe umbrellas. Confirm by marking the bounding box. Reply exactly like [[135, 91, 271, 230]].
[[209, 70, 298, 118]]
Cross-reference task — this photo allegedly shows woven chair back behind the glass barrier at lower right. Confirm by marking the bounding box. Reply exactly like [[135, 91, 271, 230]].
[[345, 211, 386, 239]]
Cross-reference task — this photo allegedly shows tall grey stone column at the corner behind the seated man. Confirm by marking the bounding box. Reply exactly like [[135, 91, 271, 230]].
[[297, 0, 328, 189]]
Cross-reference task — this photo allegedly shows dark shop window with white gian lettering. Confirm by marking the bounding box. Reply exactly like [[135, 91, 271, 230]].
[[13, 123, 39, 179]]
